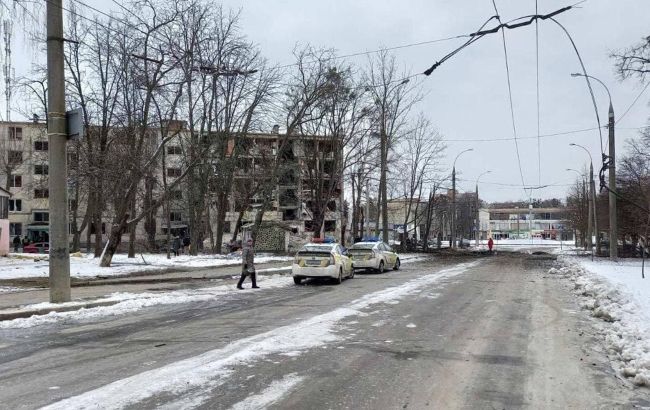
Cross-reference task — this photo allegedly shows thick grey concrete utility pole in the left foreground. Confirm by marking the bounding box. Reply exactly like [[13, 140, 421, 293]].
[[47, 0, 70, 303]]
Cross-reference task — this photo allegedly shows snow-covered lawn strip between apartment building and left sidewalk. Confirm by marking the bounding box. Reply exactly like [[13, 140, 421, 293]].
[[0, 253, 293, 279]]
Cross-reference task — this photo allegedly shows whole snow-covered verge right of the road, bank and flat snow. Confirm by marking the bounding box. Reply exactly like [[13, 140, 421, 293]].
[[549, 257, 650, 386]]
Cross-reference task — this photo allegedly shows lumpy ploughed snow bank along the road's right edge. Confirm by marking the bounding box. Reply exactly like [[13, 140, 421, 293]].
[[548, 258, 650, 386]]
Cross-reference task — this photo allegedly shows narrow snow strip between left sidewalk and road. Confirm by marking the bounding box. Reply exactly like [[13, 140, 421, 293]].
[[0, 275, 293, 329]]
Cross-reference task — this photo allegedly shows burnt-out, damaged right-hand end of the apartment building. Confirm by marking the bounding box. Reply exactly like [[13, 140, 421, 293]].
[[224, 126, 345, 250]]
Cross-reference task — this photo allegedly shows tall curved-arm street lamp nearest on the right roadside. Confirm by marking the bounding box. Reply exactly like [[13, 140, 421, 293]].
[[571, 73, 618, 261]]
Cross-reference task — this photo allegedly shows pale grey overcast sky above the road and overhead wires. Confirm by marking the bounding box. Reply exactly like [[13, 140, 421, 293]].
[[10, 0, 650, 202]]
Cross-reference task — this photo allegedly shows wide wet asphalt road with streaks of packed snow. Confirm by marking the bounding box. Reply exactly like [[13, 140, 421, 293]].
[[0, 253, 650, 409]]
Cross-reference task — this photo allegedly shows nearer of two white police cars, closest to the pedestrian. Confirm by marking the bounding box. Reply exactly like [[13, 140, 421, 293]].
[[291, 243, 354, 285]]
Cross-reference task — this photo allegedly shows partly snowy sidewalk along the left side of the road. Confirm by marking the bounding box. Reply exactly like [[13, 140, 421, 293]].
[[0, 262, 291, 321]]
